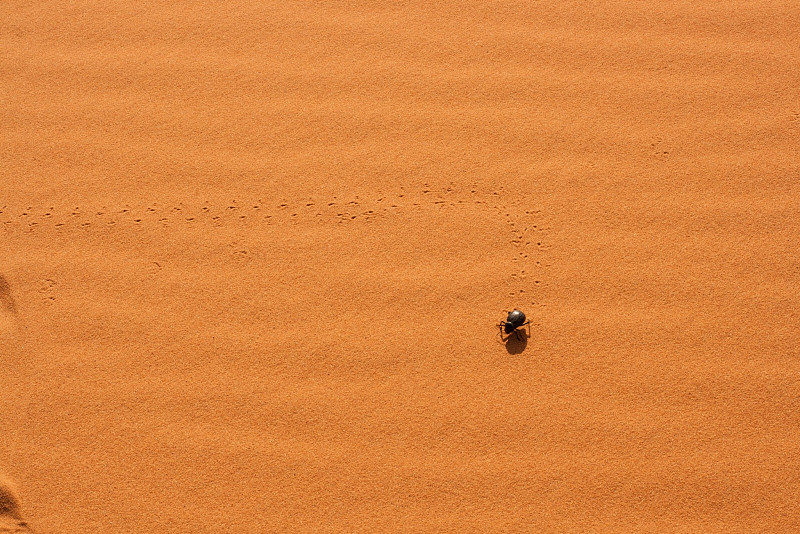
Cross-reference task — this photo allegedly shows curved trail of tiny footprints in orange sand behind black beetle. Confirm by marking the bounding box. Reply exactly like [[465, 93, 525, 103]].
[[0, 184, 548, 306]]
